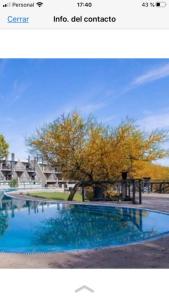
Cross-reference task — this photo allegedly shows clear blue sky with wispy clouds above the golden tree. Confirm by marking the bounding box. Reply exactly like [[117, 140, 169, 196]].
[[0, 59, 169, 164]]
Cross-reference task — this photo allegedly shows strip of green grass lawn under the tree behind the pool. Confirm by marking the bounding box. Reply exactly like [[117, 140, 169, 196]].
[[27, 192, 82, 202]]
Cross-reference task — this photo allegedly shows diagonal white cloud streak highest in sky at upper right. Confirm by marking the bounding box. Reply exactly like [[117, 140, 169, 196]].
[[131, 64, 169, 87]]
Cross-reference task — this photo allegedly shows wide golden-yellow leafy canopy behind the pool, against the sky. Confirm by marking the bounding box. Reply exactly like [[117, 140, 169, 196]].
[[28, 113, 168, 181]]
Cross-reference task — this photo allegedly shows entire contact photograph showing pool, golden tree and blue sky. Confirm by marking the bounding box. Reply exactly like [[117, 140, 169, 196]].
[[0, 58, 169, 269]]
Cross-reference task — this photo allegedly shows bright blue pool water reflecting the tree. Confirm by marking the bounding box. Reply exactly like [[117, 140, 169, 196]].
[[0, 200, 169, 253]]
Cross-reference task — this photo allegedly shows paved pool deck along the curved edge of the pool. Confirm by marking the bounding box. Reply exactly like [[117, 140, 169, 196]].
[[0, 194, 169, 269]]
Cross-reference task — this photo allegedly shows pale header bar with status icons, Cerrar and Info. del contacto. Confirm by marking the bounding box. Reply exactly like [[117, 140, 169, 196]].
[[0, 0, 169, 29]]
